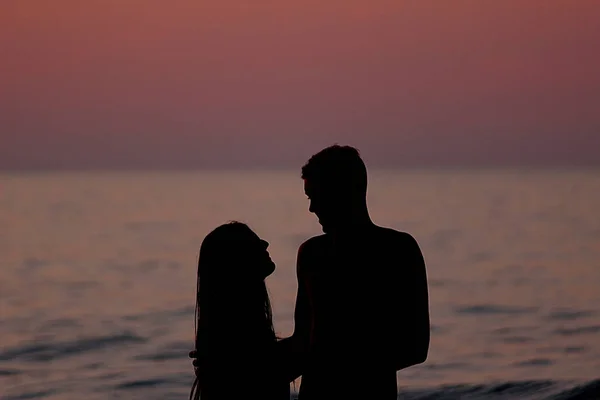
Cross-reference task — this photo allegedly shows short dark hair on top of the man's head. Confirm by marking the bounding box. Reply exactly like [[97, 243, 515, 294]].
[[302, 144, 367, 195]]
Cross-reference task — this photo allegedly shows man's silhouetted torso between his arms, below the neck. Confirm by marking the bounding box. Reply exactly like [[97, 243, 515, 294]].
[[300, 227, 410, 399]]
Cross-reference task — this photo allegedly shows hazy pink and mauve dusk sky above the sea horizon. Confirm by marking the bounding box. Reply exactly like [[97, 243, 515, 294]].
[[0, 0, 600, 170]]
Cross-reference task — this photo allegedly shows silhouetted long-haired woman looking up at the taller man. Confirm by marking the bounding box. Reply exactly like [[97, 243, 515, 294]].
[[190, 221, 290, 400]]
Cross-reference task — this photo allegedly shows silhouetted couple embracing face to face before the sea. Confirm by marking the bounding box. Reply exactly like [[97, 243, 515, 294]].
[[190, 145, 430, 400]]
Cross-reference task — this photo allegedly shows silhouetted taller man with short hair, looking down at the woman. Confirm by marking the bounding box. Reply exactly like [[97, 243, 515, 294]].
[[278, 145, 430, 400]]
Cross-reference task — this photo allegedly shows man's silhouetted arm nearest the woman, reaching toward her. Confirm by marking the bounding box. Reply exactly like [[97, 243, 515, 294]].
[[277, 244, 312, 382]]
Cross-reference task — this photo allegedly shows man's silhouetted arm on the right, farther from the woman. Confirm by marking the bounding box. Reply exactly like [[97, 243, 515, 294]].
[[394, 234, 430, 371]]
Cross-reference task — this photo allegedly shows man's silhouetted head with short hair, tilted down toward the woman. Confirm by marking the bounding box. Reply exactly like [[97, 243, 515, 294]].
[[302, 145, 367, 232]]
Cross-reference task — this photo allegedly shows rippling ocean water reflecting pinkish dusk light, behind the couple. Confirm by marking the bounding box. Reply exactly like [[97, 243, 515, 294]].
[[0, 170, 600, 400]]
